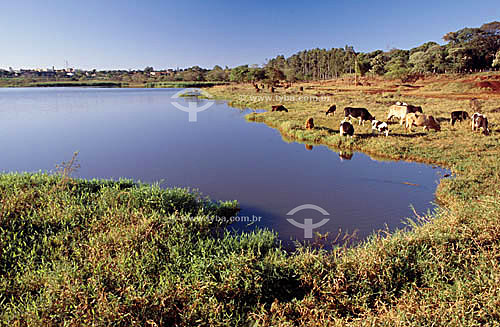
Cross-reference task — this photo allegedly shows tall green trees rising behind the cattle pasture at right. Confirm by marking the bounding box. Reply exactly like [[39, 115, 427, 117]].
[[260, 22, 500, 81]]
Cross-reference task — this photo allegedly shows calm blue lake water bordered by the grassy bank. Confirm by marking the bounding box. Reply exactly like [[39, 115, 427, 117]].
[[0, 88, 445, 247]]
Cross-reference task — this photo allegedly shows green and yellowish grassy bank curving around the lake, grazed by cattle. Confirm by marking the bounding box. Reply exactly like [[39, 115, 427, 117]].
[[0, 75, 500, 326]]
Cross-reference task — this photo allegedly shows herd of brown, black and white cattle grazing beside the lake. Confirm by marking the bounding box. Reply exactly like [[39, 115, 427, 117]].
[[272, 102, 490, 137]]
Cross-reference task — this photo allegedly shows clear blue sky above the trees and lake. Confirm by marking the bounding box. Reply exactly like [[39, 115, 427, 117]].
[[0, 0, 500, 69]]
